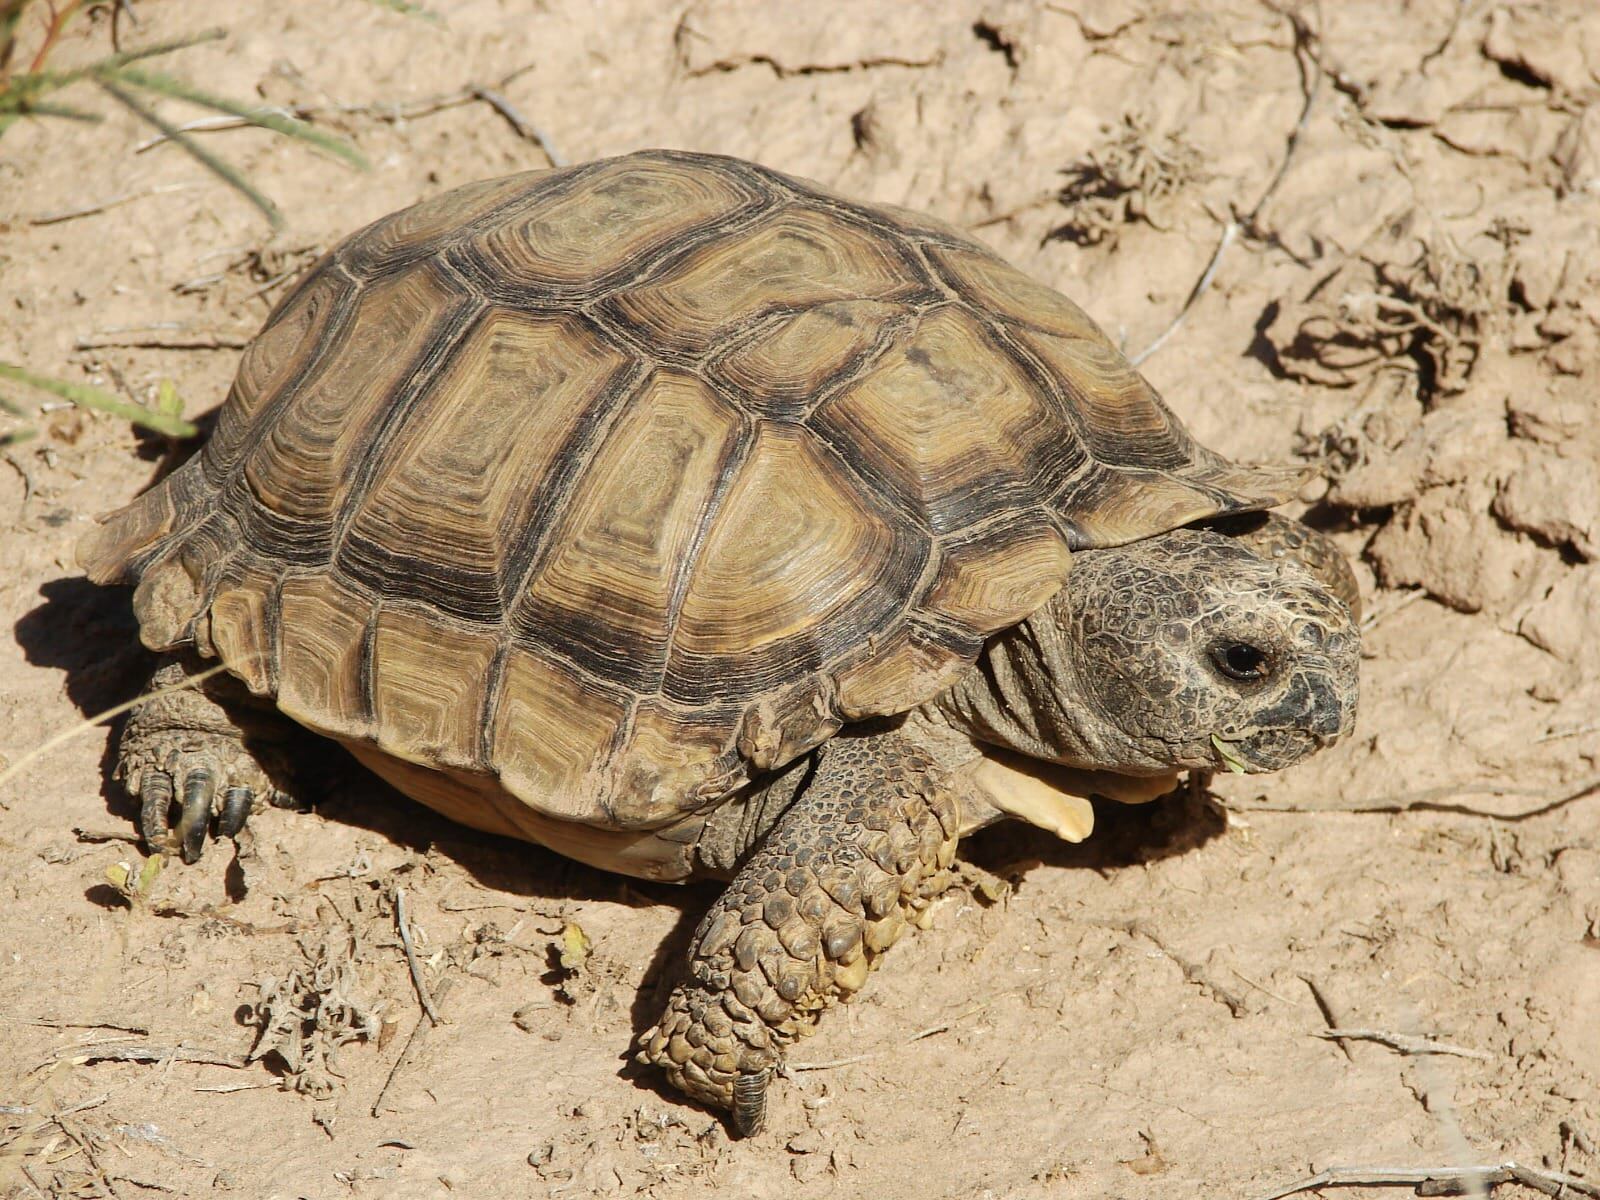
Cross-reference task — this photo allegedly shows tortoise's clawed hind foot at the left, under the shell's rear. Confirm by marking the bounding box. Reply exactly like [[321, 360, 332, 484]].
[[117, 654, 293, 862]]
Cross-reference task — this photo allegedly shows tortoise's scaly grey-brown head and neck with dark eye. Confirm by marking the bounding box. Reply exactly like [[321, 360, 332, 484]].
[[942, 530, 1360, 776]]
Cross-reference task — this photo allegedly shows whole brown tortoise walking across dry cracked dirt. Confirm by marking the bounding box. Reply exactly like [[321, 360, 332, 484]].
[[78, 150, 1358, 1133]]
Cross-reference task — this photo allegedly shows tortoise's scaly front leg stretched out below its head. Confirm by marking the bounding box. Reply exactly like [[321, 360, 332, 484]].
[[638, 731, 960, 1134]]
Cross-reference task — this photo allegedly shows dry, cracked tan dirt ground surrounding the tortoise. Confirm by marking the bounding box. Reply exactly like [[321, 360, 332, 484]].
[[0, 0, 1600, 1200]]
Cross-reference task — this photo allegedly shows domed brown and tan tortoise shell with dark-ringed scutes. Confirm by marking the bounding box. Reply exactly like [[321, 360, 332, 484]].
[[80, 152, 1299, 830]]
